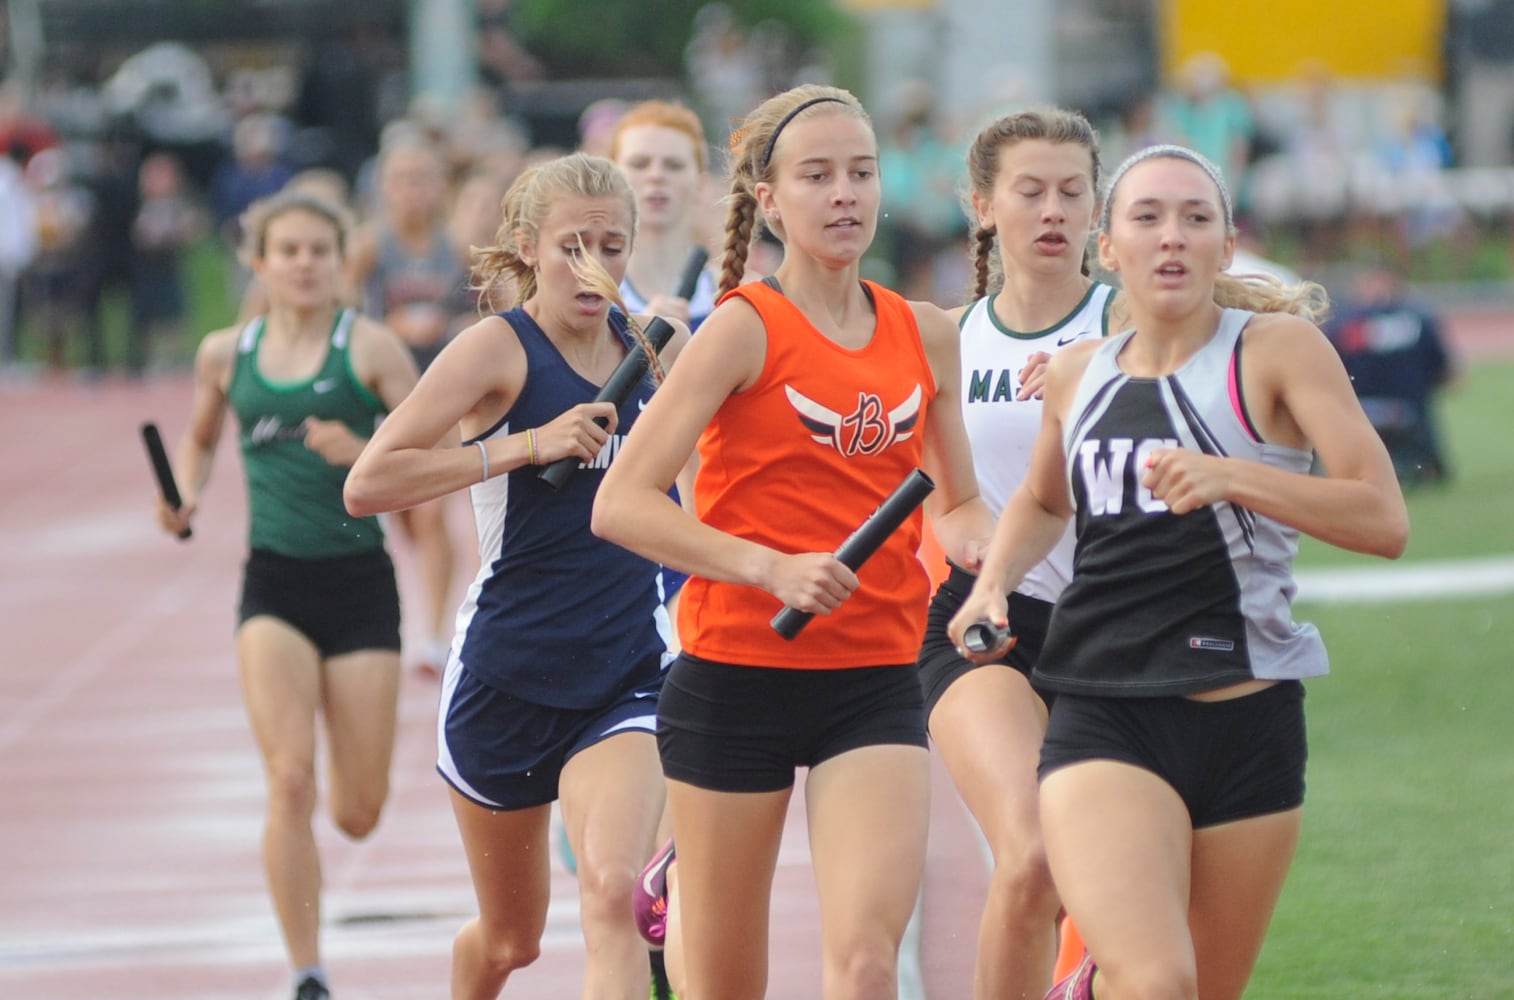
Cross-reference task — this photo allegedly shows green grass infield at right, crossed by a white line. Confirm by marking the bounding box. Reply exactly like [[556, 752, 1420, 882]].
[[1248, 362, 1514, 1000]]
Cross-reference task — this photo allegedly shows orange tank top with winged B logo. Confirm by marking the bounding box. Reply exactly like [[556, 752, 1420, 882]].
[[678, 281, 936, 669]]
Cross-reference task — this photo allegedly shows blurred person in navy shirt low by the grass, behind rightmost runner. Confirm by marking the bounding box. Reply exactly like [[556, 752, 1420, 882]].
[[1325, 262, 1459, 484]]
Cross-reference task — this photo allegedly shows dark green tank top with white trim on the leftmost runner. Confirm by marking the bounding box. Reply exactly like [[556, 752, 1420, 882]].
[[226, 309, 385, 558]]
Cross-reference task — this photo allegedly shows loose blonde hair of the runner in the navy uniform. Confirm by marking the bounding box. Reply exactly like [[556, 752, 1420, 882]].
[[469, 153, 663, 381]]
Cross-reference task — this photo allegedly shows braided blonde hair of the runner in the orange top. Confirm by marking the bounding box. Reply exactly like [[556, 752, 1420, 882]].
[[719, 83, 872, 295]]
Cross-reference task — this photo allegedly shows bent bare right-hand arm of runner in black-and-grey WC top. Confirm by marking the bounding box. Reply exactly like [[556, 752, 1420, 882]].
[[1142, 315, 1410, 558]]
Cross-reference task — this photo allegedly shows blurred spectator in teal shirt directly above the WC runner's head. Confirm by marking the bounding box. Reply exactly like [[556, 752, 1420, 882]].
[[1160, 51, 1257, 200]]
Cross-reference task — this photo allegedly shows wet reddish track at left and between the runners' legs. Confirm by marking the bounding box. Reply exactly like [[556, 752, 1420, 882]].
[[0, 378, 984, 1000]]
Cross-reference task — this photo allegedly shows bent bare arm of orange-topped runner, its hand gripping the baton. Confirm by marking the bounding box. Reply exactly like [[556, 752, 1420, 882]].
[[592, 300, 857, 614]]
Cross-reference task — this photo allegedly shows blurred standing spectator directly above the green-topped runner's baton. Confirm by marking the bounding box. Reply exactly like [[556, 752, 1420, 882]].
[[126, 153, 206, 375]]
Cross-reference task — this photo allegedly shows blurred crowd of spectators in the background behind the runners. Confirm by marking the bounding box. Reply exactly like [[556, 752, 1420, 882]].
[[0, 3, 1514, 429]]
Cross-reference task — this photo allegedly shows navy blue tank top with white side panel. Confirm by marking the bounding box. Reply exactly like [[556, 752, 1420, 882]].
[[445, 309, 671, 710]]
